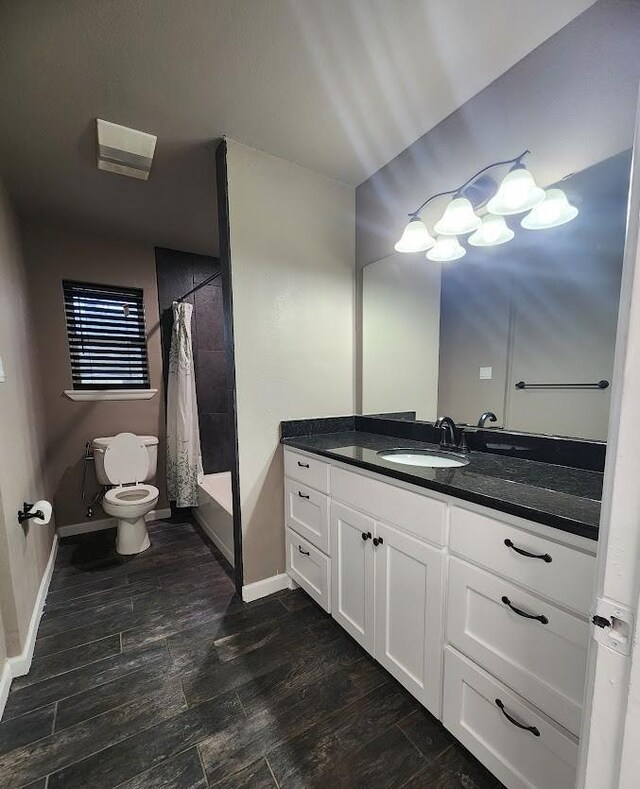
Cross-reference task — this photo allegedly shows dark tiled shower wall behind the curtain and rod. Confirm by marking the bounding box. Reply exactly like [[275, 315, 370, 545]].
[[155, 247, 233, 474]]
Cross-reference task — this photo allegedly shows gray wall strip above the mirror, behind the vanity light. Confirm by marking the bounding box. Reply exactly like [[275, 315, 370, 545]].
[[356, 0, 640, 266]]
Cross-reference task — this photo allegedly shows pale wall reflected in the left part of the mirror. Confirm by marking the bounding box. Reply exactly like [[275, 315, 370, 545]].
[[362, 253, 441, 421]]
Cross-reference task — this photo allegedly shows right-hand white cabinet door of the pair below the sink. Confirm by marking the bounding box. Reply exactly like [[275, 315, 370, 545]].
[[374, 522, 445, 717]]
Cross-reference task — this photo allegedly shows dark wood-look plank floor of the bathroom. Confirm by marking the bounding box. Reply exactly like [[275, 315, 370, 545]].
[[0, 522, 501, 789]]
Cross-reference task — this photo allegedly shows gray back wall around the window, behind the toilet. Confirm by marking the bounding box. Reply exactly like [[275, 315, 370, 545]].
[[21, 223, 166, 526]]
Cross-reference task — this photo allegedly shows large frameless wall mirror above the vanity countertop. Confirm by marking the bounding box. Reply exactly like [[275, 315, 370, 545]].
[[361, 151, 631, 440]]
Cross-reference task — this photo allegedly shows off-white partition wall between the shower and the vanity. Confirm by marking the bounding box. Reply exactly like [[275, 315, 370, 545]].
[[227, 140, 355, 583]]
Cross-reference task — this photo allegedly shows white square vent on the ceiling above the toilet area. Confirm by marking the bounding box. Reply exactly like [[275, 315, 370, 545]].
[[96, 118, 158, 181]]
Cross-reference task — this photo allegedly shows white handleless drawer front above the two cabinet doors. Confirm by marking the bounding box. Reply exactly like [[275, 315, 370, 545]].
[[331, 467, 447, 546]]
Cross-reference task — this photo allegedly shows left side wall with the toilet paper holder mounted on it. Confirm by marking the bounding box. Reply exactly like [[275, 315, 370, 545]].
[[0, 182, 53, 657]]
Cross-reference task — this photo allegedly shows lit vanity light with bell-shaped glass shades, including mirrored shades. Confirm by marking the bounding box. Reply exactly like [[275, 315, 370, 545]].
[[394, 151, 578, 261]]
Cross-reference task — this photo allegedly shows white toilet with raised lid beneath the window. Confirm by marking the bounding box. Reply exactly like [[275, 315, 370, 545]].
[[93, 433, 160, 556]]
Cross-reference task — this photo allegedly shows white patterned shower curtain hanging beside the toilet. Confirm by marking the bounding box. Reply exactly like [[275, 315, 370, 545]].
[[167, 302, 202, 507]]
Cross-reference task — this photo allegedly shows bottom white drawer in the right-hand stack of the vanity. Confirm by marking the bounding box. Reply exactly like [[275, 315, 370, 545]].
[[443, 647, 578, 789]]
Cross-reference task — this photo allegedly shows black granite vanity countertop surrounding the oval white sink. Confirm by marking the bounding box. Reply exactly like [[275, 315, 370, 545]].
[[282, 430, 603, 540]]
